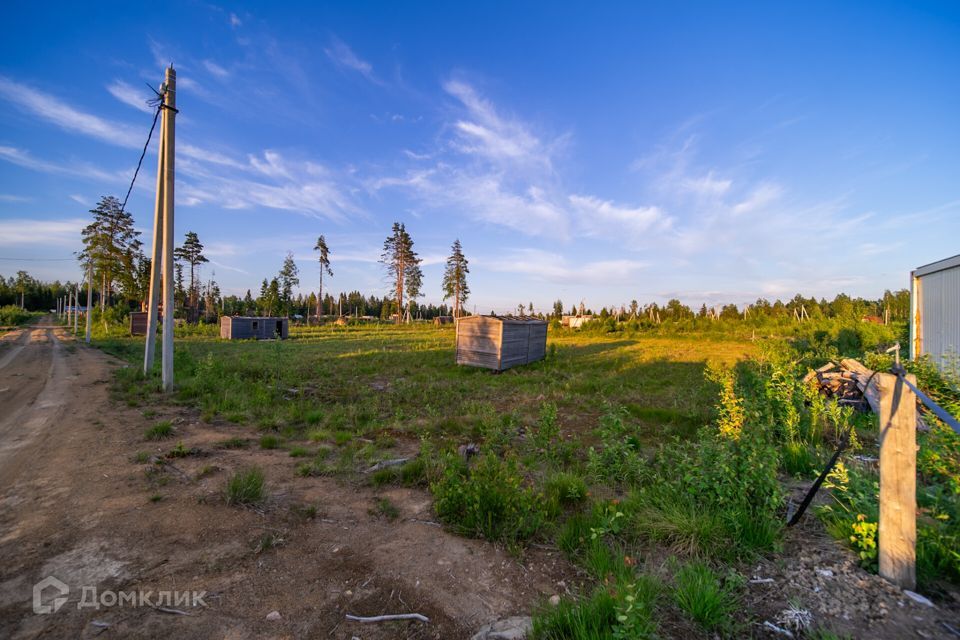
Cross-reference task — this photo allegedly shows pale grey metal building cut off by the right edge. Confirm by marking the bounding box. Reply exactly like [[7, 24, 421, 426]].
[[910, 255, 960, 368]]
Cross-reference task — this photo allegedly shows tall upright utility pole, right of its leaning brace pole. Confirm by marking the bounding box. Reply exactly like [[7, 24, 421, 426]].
[[161, 66, 177, 392]]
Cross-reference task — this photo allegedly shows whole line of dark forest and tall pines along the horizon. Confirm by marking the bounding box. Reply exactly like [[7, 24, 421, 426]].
[[0, 196, 910, 324]]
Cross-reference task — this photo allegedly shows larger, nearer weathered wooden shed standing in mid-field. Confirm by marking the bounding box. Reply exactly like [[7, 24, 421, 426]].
[[457, 316, 547, 371]]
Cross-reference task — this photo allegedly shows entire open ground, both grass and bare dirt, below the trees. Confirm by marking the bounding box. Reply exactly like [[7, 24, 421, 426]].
[[0, 325, 960, 638]]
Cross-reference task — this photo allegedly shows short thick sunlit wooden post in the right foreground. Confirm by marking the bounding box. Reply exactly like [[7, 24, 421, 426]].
[[876, 373, 917, 589]]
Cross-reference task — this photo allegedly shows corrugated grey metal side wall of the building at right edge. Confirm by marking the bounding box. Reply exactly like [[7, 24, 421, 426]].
[[919, 267, 960, 376]]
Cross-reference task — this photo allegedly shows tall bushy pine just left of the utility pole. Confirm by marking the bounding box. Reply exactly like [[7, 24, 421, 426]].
[[78, 196, 141, 310]]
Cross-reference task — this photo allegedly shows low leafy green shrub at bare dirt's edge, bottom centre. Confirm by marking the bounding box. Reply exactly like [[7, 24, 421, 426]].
[[430, 453, 544, 543]]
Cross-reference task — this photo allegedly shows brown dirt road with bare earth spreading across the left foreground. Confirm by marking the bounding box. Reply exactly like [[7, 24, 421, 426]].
[[0, 320, 570, 639]]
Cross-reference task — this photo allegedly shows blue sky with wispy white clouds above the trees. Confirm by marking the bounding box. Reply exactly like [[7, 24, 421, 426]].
[[0, 1, 960, 312]]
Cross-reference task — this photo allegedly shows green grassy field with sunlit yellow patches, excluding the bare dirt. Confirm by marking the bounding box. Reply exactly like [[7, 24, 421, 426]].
[[84, 323, 960, 638]]
